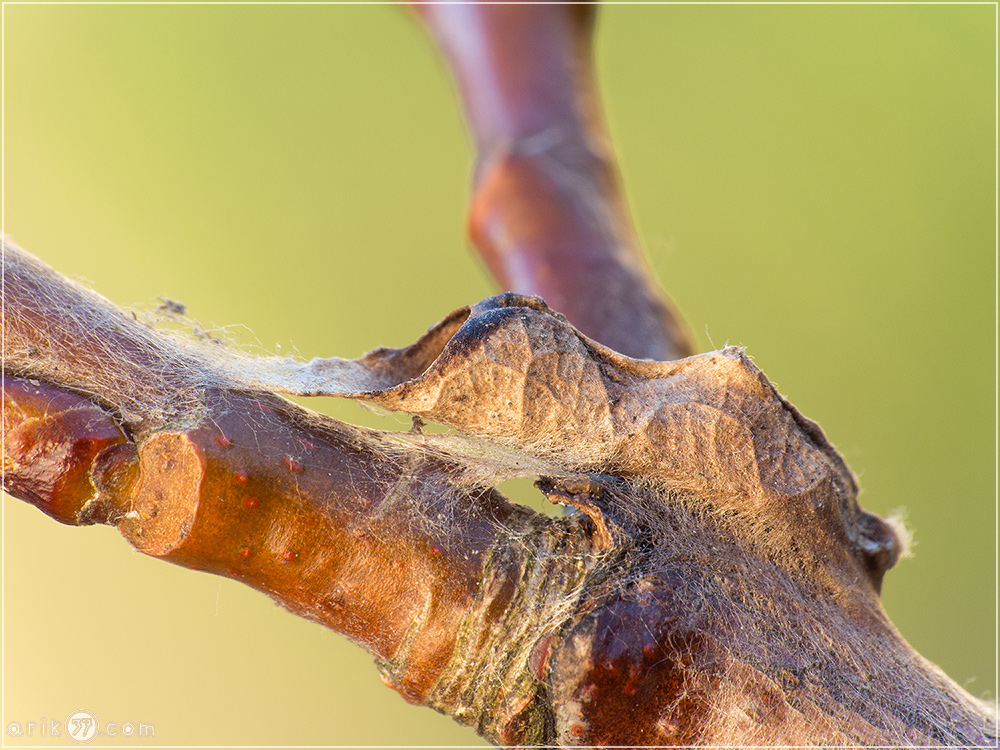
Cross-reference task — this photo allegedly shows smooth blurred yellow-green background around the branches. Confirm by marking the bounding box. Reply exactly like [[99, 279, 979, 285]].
[[3, 5, 996, 745]]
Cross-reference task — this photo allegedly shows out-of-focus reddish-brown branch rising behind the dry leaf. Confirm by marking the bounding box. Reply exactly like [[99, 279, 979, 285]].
[[415, 3, 695, 360]]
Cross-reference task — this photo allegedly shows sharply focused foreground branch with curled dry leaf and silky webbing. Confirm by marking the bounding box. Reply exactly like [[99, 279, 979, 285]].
[[4, 244, 996, 745]]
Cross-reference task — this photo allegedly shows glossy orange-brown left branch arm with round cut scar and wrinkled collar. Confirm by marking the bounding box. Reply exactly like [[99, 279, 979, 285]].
[[3, 243, 589, 742]]
